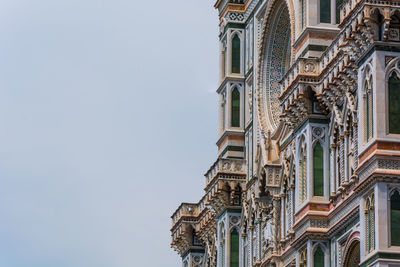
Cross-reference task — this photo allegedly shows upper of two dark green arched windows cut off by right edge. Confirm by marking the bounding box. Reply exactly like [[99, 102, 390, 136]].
[[389, 72, 400, 134]]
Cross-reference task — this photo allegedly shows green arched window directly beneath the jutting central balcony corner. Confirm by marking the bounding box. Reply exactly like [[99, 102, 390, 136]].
[[313, 142, 324, 196]]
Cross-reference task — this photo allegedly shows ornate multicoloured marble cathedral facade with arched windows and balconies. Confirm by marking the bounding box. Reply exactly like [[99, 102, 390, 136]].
[[171, 0, 400, 267]]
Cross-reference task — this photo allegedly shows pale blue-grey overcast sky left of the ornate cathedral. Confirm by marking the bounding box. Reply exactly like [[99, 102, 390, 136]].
[[0, 0, 218, 267]]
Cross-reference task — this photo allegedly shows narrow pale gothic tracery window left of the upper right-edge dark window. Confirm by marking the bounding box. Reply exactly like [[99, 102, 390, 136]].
[[364, 69, 374, 142]]
